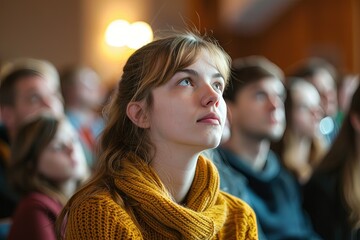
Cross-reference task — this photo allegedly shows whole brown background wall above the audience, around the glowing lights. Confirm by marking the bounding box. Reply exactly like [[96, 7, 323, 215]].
[[0, 0, 360, 83]]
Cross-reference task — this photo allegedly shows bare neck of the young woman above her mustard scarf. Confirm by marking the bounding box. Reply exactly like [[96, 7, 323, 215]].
[[150, 147, 199, 203]]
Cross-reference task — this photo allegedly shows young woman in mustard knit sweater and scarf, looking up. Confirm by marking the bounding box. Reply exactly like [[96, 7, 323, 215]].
[[58, 33, 257, 239]]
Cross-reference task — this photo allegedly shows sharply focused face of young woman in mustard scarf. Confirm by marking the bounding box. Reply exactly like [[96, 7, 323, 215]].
[[149, 51, 226, 151]]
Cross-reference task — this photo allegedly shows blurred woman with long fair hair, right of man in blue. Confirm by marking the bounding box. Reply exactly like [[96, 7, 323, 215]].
[[271, 78, 326, 184]]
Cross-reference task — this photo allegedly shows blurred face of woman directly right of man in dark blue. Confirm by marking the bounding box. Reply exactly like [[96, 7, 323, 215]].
[[291, 81, 323, 138]]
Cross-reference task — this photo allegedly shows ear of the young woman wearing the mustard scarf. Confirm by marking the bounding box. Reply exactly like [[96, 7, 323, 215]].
[[126, 102, 150, 128]]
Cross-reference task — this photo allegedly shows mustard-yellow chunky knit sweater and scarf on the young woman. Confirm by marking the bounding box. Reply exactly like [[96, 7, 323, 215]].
[[66, 157, 257, 240]]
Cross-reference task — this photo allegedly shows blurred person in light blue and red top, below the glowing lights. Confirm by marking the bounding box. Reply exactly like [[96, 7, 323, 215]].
[[61, 67, 105, 166]]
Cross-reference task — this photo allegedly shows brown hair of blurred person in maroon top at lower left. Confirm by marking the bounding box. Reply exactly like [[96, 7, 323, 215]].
[[9, 114, 66, 204]]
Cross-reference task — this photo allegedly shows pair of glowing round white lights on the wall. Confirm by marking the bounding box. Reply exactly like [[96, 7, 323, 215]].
[[105, 20, 153, 49]]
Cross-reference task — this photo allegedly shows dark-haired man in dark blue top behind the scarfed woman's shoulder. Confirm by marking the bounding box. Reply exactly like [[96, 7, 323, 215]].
[[213, 56, 317, 240]]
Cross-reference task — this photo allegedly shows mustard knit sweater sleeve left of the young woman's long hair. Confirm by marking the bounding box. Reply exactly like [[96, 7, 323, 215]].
[[65, 194, 142, 240]]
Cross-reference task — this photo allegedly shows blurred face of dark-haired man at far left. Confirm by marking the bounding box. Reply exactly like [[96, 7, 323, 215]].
[[12, 76, 64, 125]]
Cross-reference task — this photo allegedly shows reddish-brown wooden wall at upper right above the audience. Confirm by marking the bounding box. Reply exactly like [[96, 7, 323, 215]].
[[189, 0, 360, 72]]
